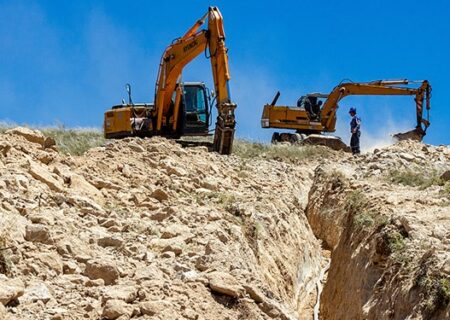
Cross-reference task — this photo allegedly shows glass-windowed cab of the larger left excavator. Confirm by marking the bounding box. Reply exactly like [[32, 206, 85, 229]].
[[180, 82, 211, 135]]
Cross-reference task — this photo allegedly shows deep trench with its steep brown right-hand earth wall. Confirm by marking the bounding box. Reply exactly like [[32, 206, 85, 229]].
[[290, 166, 449, 319]]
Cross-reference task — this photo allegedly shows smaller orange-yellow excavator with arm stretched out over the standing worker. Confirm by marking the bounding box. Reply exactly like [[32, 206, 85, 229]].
[[261, 79, 431, 150]]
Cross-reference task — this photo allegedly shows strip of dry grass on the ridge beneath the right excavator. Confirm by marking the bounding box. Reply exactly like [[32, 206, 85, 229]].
[[233, 139, 333, 161]]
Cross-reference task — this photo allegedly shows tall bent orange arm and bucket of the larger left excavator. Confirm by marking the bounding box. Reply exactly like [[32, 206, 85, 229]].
[[155, 7, 236, 154]]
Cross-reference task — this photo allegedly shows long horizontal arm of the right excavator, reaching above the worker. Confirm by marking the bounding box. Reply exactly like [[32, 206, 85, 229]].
[[321, 80, 431, 136]]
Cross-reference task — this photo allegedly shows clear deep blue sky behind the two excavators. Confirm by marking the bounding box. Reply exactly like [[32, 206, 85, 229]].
[[0, 0, 450, 148]]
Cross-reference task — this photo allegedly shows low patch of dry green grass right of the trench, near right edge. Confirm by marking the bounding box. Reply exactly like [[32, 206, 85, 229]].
[[387, 169, 444, 189]]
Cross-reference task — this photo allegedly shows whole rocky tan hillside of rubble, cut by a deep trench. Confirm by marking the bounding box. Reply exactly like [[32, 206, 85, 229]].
[[0, 128, 450, 320]]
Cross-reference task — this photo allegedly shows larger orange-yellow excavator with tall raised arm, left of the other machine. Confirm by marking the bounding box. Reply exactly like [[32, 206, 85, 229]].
[[104, 7, 236, 154]]
